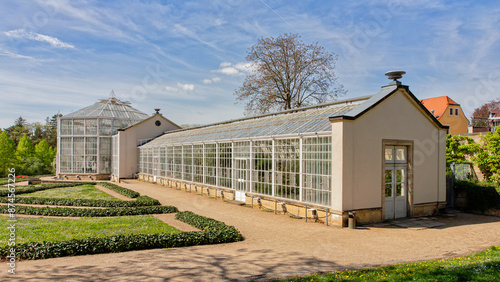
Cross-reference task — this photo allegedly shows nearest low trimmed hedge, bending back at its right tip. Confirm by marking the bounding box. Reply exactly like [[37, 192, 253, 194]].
[[0, 212, 243, 260]]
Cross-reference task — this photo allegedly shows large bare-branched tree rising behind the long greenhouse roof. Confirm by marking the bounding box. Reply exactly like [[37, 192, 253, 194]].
[[234, 34, 345, 115]]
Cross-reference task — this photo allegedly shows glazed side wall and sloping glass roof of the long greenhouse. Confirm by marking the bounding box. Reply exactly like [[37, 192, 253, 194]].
[[138, 99, 364, 206]]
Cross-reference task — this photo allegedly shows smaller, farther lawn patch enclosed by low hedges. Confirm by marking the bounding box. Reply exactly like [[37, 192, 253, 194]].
[[18, 184, 120, 201]]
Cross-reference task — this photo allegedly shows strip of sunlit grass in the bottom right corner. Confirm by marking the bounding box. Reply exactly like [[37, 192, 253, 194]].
[[282, 246, 500, 281]]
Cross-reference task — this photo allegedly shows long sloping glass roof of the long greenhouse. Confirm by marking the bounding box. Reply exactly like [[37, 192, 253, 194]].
[[141, 97, 369, 147]]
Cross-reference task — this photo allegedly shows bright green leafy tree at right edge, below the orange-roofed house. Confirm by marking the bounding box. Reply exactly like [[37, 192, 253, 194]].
[[474, 126, 500, 182]]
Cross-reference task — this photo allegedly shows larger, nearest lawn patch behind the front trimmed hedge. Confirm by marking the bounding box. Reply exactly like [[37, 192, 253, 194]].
[[0, 215, 181, 247]]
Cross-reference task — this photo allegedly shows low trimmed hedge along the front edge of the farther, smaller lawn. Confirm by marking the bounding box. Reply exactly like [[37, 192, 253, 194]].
[[0, 196, 160, 207]]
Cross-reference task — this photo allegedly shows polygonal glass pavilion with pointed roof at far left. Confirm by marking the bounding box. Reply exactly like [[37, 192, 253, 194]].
[[56, 92, 148, 178]]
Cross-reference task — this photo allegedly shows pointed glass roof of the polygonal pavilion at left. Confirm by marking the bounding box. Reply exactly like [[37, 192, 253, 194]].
[[61, 97, 149, 121]]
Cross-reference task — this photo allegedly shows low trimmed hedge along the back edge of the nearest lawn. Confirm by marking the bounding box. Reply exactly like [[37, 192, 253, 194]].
[[0, 205, 178, 217]]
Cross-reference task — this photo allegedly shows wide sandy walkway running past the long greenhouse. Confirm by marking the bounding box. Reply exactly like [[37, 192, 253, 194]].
[[0, 180, 500, 281]]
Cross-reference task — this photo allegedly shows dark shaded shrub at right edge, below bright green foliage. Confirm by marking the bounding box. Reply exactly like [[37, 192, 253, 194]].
[[455, 180, 500, 212]]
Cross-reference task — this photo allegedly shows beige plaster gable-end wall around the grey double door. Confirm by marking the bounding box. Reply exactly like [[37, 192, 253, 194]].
[[332, 89, 446, 211]]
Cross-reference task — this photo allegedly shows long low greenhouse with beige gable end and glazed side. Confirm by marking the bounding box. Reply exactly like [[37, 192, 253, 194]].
[[135, 72, 448, 225]]
